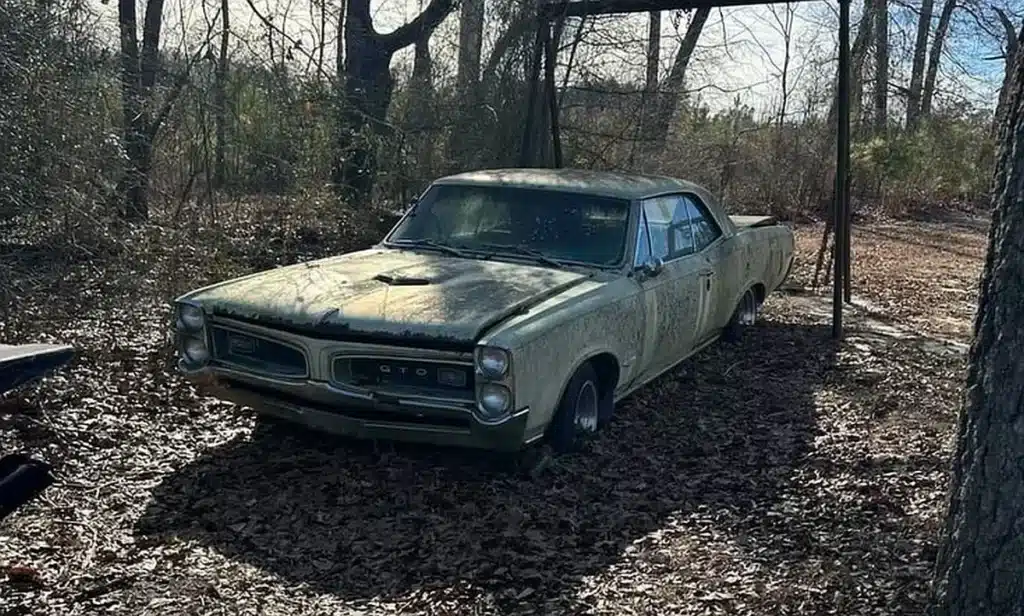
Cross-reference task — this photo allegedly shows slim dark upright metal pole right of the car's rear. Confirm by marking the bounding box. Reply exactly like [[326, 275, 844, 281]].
[[833, 0, 850, 340]]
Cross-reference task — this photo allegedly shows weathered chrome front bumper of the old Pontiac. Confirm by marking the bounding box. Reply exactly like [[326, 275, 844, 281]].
[[178, 361, 536, 451]]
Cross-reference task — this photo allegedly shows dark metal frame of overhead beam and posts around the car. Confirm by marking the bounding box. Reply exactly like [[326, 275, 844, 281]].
[[519, 0, 851, 339]]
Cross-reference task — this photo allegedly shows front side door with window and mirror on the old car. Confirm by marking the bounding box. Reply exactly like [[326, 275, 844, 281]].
[[635, 194, 707, 380]]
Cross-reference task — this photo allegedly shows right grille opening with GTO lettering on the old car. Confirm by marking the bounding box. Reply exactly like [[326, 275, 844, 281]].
[[332, 356, 475, 400]]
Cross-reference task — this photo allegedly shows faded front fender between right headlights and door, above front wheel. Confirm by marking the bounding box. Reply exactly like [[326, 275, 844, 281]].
[[481, 276, 644, 439]]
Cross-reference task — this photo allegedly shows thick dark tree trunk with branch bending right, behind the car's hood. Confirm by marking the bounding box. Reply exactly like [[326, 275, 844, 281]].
[[332, 0, 454, 203]]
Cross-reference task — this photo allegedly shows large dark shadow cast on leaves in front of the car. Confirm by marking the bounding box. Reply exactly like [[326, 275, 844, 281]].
[[135, 321, 836, 609]]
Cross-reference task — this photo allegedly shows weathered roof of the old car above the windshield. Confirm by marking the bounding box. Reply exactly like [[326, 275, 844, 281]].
[[433, 169, 705, 201]]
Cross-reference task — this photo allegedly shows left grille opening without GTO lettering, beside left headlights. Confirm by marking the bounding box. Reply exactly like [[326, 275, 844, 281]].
[[211, 325, 309, 379]]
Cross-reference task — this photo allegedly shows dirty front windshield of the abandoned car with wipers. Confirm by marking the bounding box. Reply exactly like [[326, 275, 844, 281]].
[[388, 184, 630, 266]]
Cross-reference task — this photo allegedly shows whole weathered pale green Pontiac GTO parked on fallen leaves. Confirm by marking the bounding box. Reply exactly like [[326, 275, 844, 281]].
[[175, 169, 794, 460]]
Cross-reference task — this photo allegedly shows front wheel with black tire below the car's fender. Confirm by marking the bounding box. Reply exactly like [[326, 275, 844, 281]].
[[548, 361, 610, 453]]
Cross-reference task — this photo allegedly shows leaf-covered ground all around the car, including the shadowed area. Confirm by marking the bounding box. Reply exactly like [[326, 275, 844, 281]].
[[0, 201, 987, 616]]
